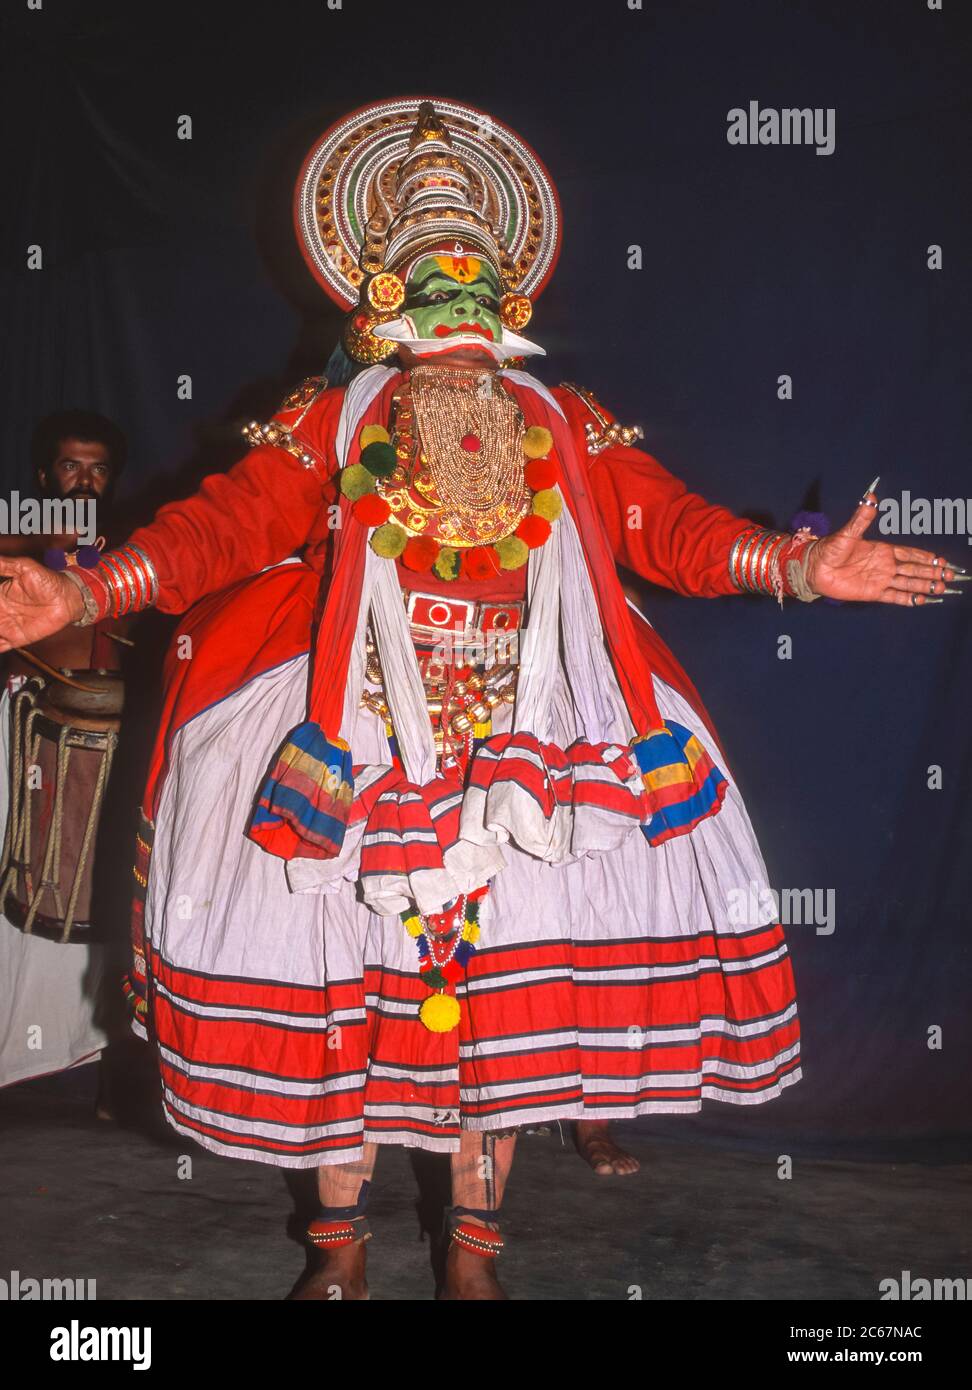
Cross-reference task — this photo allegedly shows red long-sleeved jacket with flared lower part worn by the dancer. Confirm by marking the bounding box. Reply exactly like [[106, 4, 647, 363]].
[[131, 377, 752, 819]]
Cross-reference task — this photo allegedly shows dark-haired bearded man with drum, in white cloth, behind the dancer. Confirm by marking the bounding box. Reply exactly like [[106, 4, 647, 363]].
[[0, 410, 128, 1086]]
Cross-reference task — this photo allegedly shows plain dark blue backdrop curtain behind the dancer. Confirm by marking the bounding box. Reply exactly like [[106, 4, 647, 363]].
[[0, 0, 972, 1155]]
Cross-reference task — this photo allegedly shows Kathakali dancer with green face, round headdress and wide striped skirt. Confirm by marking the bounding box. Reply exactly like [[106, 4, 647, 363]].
[[0, 99, 953, 1298]]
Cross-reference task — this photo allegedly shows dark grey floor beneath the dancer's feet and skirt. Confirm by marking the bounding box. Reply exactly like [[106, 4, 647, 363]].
[[0, 1050, 972, 1300]]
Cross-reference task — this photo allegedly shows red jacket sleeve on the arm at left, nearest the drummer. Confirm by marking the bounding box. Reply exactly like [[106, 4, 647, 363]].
[[129, 388, 343, 613]]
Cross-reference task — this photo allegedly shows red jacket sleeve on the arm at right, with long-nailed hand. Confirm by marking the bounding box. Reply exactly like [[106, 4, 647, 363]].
[[555, 386, 755, 598]]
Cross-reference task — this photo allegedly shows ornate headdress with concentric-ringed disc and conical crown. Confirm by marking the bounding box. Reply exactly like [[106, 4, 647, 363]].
[[295, 97, 560, 309]]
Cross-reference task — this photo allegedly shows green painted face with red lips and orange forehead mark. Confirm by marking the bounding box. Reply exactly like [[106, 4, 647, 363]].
[[402, 256, 503, 342]]
